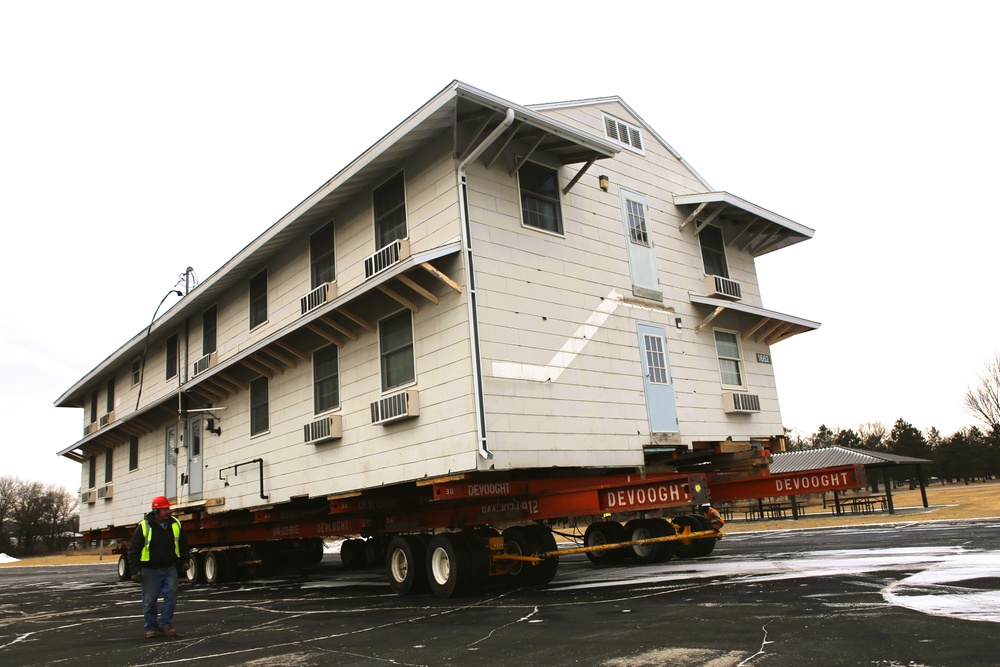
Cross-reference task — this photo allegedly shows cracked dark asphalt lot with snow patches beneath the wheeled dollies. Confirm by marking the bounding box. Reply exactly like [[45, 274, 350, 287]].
[[0, 519, 1000, 667]]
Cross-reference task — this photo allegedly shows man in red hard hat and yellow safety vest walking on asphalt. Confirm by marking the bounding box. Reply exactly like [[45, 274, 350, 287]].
[[128, 496, 188, 638]]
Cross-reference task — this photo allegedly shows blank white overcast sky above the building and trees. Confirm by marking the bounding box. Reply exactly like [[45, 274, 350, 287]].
[[0, 0, 1000, 491]]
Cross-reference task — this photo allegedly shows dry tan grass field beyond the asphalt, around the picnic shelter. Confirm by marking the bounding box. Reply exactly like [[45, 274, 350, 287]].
[[0, 482, 1000, 568]]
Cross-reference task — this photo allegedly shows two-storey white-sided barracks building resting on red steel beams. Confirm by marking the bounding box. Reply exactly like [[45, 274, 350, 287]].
[[56, 81, 819, 530]]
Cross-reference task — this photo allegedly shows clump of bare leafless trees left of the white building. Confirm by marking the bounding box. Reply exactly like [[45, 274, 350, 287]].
[[0, 475, 80, 556]]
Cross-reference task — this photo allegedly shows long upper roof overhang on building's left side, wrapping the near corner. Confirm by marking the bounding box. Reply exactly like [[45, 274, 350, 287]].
[[55, 81, 621, 407]]
